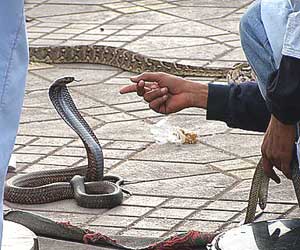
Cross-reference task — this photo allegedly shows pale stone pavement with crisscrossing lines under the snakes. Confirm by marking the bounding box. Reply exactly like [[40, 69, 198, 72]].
[[6, 0, 299, 248]]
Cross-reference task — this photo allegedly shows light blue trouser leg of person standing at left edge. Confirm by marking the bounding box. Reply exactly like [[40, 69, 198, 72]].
[[0, 0, 28, 248]]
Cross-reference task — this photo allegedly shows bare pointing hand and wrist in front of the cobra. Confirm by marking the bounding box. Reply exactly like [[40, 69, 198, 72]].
[[120, 72, 208, 114]]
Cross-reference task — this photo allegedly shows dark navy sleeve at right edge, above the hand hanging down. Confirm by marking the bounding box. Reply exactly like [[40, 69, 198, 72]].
[[266, 56, 300, 124]]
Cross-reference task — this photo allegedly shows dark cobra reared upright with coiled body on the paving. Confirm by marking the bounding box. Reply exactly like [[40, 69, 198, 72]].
[[4, 77, 123, 208]]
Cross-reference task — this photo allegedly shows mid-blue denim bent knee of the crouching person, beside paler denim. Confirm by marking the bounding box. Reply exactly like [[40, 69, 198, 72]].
[[240, 1, 276, 97]]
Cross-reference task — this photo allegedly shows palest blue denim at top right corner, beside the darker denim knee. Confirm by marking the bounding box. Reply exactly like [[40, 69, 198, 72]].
[[261, 0, 300, 68]]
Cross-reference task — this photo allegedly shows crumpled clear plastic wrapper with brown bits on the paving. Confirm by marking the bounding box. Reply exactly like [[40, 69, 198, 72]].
[[150, 119, 198, 144]]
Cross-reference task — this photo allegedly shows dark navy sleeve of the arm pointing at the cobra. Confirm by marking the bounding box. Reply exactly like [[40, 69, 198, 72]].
[[206, 82, 270, 132]]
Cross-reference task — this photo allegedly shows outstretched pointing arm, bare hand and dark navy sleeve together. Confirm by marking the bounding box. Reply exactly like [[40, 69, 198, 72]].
[[120, 73, 270, 132]]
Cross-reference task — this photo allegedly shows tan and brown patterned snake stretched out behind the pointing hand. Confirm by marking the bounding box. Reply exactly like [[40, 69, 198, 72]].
[[29, 45, 255, 82]]
